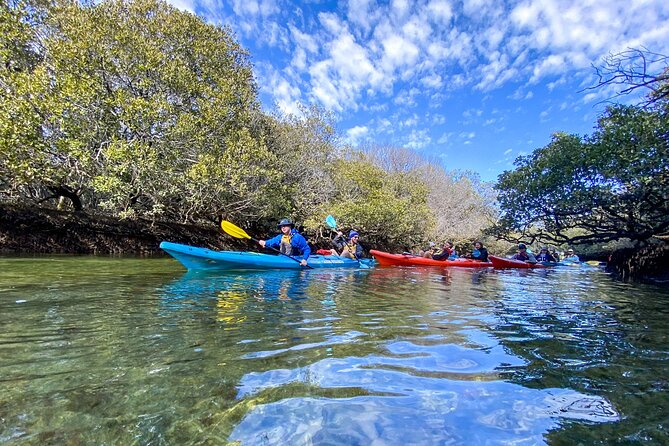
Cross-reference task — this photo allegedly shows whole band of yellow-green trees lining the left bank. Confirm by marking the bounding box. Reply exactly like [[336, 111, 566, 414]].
[[0, 0, 496, 249]]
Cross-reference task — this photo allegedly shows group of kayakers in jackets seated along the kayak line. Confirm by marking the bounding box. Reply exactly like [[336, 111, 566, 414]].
[[258, 218, 580, 266]]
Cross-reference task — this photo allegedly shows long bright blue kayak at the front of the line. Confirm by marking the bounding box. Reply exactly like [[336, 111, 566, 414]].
[[160, 242, 369, 270]]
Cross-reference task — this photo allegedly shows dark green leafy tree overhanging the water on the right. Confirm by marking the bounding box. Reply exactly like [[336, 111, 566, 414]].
[[496, 106, 669, 243]]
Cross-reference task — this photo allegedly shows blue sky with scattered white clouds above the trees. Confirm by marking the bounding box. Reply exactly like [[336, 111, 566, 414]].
[[170, 0, 669, 180]]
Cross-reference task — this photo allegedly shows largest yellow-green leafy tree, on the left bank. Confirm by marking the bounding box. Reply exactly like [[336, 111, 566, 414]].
[[0, 0, 280, 219]]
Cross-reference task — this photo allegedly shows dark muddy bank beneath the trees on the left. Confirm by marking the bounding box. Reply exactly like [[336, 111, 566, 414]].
[[0, 205, 237, 255]]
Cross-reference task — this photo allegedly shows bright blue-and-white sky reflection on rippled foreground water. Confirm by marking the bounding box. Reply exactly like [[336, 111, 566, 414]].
[[230, 342, 618, 445]]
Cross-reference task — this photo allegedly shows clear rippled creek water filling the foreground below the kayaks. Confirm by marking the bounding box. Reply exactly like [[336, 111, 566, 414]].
[[0, 257, 669, 445]]
